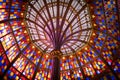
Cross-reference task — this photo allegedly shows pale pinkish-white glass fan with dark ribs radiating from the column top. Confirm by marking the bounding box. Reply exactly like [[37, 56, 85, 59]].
[[26, 0, 92, 55]]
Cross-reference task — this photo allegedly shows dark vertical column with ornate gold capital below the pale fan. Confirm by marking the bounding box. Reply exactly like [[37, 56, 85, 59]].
[[51, 50, 61, 80]]
